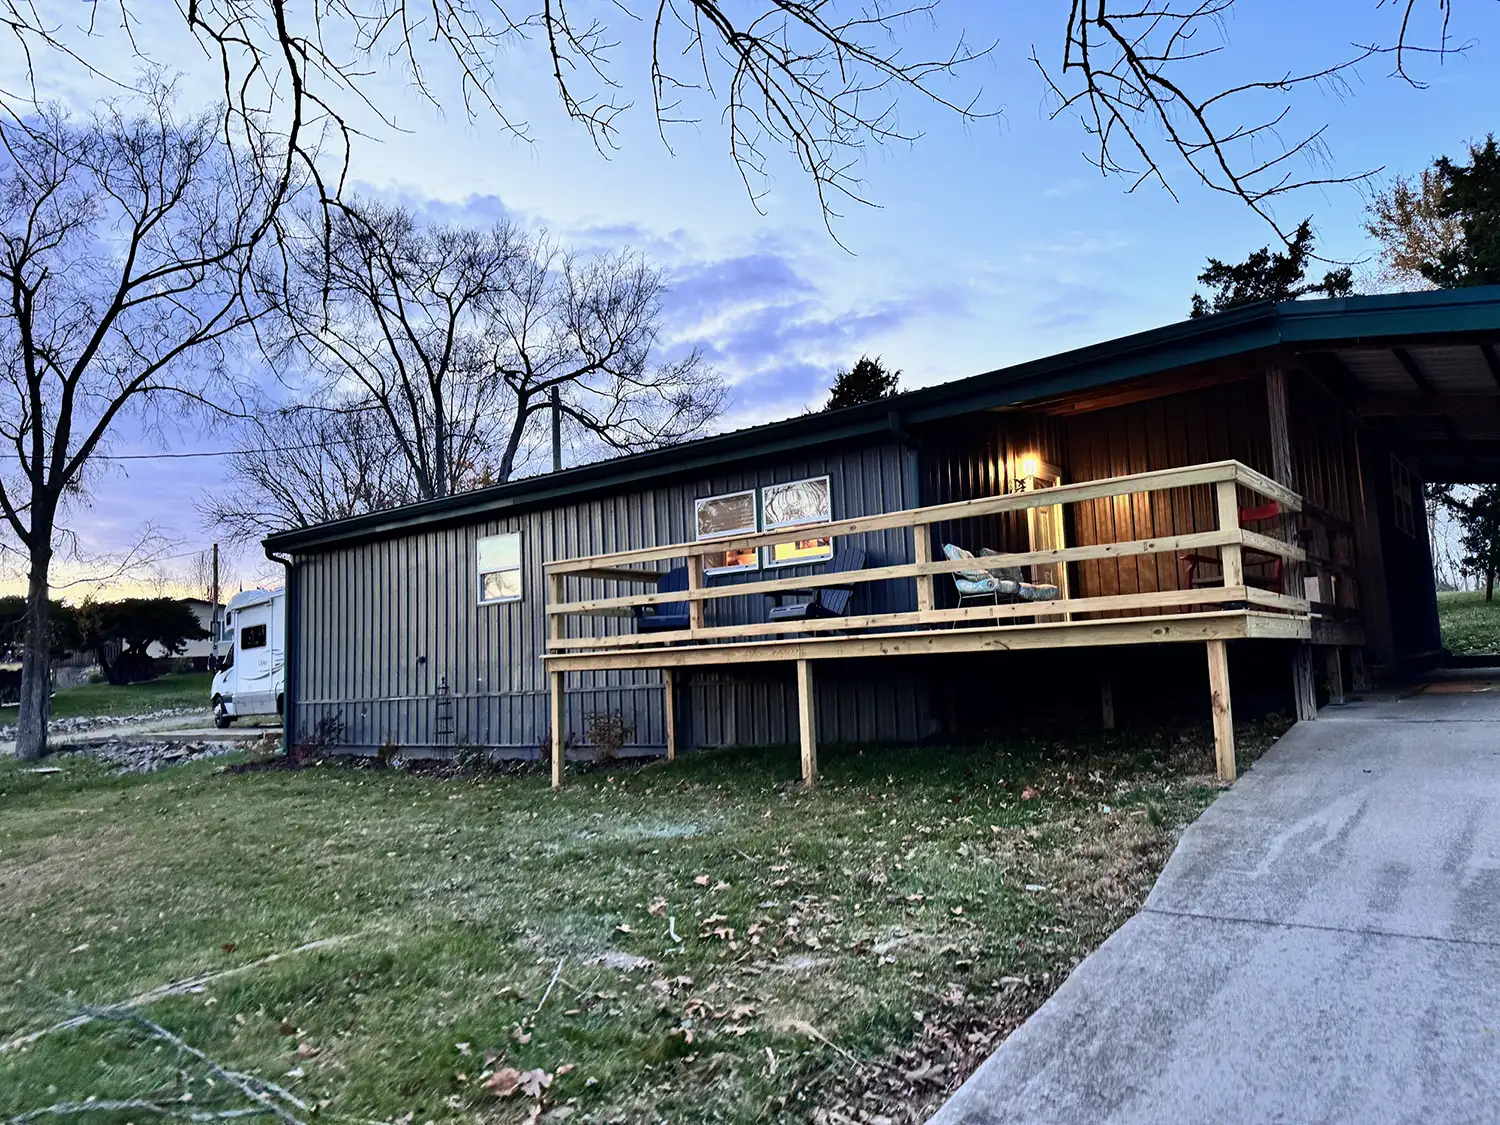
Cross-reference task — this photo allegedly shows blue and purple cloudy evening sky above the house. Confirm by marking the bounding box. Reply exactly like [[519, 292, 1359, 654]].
[[0, 0, 1500, 596]]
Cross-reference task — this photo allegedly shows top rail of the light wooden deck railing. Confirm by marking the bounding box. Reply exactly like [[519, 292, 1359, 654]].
[[545, 461, 1302, 581]]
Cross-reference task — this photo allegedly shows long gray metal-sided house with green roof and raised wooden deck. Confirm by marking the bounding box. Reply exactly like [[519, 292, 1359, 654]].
[[266, 290, 1500, 780]]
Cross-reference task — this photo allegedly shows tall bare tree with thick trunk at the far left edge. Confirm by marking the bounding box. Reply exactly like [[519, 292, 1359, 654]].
[[0, 84, 275, 758]]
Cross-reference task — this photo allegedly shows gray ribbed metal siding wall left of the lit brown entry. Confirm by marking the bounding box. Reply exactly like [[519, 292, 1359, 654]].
[[293, 443, 929, 756]]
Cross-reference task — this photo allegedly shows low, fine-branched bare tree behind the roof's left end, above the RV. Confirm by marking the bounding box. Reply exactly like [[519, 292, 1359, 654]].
[[200, 404, 417, 543]]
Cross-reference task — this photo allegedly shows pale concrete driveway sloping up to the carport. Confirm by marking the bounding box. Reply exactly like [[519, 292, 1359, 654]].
[[933, 683, 1500, 1125]]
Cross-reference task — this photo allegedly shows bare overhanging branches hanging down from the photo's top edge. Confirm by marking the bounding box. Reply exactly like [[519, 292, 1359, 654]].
[[0, 0, 1467, 234]]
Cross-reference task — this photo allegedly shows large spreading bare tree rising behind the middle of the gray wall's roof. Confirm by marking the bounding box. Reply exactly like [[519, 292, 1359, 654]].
[[273, 201, 723, 507]]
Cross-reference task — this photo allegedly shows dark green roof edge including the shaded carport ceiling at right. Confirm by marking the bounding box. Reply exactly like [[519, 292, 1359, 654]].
[[266, 287, 1500, 554]]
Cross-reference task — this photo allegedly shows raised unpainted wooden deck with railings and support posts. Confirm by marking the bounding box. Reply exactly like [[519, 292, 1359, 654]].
[[545, 461, 1344, 786]]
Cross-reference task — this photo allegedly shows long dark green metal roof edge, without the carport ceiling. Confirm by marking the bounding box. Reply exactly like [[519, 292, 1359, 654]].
[[264, 287, 1500, 554]]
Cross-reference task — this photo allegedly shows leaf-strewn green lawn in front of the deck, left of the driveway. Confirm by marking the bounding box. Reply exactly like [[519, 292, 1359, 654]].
[[0, 726, 1275, 1125]]
